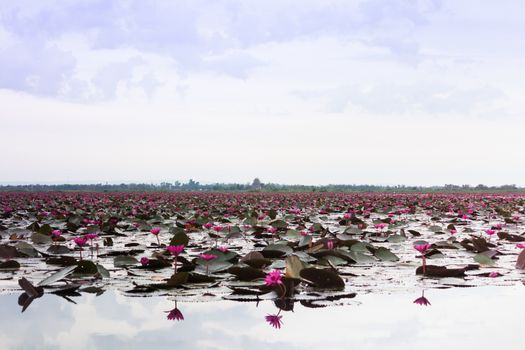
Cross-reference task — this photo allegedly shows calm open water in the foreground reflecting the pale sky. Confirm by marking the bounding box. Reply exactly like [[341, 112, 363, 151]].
[[0, 284, 525, 350]]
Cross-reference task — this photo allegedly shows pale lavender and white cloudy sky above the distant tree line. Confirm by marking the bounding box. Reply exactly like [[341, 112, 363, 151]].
[[0, 0, 525, 186]]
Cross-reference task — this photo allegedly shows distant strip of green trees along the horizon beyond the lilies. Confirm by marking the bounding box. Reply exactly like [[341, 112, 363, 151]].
[[0, 178, 525, 193]]
